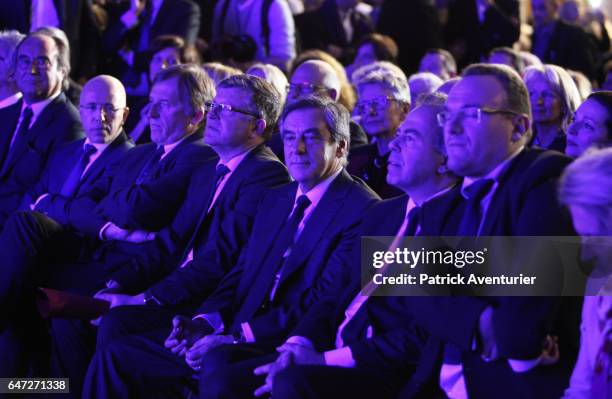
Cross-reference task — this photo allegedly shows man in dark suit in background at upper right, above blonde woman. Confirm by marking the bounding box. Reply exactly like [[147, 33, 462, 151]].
[[531, 0, 600, 79]]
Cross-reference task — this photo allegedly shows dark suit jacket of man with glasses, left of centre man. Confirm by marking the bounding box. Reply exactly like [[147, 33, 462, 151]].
[[112, 145, 290, 305]]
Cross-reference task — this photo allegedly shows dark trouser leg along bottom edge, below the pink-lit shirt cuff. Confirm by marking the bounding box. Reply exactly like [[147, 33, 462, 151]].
[[272, 365, 401, 399]]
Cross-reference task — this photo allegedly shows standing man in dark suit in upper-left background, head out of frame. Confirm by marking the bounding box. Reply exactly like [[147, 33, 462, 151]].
[[102, 0, 200, 95]]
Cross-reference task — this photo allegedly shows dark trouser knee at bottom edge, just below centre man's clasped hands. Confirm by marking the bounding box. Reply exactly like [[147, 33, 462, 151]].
[[200, 344, 278, 399]]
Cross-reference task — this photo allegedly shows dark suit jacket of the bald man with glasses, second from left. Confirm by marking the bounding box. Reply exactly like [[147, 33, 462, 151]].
[[21, 132, 134, 225]]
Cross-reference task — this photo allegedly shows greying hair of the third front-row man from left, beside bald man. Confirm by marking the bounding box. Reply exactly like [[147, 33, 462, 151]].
[[153, 64, 215, 120]]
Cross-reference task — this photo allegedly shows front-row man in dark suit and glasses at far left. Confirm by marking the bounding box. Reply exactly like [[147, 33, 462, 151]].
[[0, 34, 82, 226]]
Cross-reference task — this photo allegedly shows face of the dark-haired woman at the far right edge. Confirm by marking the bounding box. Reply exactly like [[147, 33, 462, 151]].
[[565, 99, 612, 158]]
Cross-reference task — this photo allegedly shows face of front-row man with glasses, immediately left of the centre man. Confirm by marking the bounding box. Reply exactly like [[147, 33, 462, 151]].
[[204, 87, 260, 151]]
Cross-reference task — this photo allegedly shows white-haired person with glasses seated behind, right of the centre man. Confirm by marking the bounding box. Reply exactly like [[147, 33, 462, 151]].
[[347, 64, 410, 198]]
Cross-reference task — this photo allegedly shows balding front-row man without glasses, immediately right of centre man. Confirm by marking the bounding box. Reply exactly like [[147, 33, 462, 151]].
[[200, 95, 457, 398]]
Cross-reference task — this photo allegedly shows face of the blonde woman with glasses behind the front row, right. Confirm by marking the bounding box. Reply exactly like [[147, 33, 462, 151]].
[[527, 74, 563, 125]]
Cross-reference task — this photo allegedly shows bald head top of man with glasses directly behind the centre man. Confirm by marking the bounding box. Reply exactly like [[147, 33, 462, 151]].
[[288, 60, 340, 101]]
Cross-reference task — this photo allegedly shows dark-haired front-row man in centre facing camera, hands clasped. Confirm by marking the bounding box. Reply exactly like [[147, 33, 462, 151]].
[[84, 97, 377, 397]]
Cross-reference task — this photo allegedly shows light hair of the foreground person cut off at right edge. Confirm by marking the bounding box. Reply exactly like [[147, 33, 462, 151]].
[[559, 148, 612, 223]]
